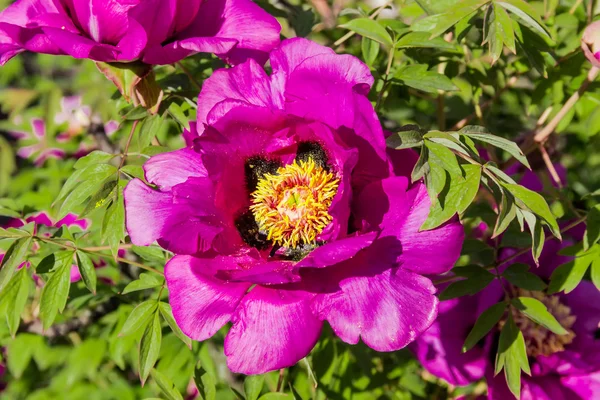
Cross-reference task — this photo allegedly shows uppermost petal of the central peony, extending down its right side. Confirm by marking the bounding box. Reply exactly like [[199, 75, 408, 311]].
[[271, 38, 389, 189]]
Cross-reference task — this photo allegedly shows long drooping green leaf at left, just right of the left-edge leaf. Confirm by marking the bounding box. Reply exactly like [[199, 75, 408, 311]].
[[40, 251, 75, 329]]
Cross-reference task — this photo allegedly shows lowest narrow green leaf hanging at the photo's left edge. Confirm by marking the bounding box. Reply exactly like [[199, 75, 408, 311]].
[[0, 268, 31, 337]]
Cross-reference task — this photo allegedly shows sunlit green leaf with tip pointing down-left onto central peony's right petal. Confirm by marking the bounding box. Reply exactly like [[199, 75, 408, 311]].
[[420, 164, 481, 230]]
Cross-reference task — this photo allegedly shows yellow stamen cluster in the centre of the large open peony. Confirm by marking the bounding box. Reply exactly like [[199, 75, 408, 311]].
[[250, 159, 339, 248]]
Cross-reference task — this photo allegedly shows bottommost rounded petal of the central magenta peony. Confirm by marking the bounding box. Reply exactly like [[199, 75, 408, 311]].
[[225, 286, 322, 374]]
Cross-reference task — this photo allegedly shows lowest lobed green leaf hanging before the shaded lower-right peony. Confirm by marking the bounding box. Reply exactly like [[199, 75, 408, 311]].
[[495, 313, 531, 399]]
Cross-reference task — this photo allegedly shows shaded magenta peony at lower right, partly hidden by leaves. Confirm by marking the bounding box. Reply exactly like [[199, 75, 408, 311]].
[[411, 233, 600, 400]]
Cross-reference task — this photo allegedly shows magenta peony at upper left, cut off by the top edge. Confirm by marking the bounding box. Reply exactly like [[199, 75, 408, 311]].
[[0, 0, 280, 64]]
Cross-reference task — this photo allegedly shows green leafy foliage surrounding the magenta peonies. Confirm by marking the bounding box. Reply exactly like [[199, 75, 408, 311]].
[[0, 0, 600, 400]]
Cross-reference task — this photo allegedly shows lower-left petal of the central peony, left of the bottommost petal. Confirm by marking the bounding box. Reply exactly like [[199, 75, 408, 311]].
[[165, 256, 250, 340]]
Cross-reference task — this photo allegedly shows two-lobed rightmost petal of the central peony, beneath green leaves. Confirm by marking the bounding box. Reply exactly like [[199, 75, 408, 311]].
[[355, 177, 464, 274]]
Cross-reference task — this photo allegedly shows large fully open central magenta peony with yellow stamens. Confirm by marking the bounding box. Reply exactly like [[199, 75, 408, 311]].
[[124, 39, 463, 374]]
